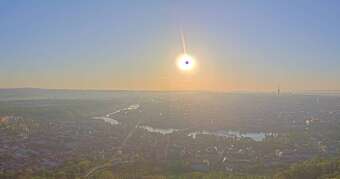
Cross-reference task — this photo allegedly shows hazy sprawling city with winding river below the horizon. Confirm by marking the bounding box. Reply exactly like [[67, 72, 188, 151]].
[[0, 90, 340, 177]]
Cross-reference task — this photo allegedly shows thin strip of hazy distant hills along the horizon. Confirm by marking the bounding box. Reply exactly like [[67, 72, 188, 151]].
[[0, 88, 340, 101]]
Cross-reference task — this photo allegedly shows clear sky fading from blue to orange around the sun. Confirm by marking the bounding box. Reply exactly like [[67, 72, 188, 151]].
[[0, 0, 340, 91]]
